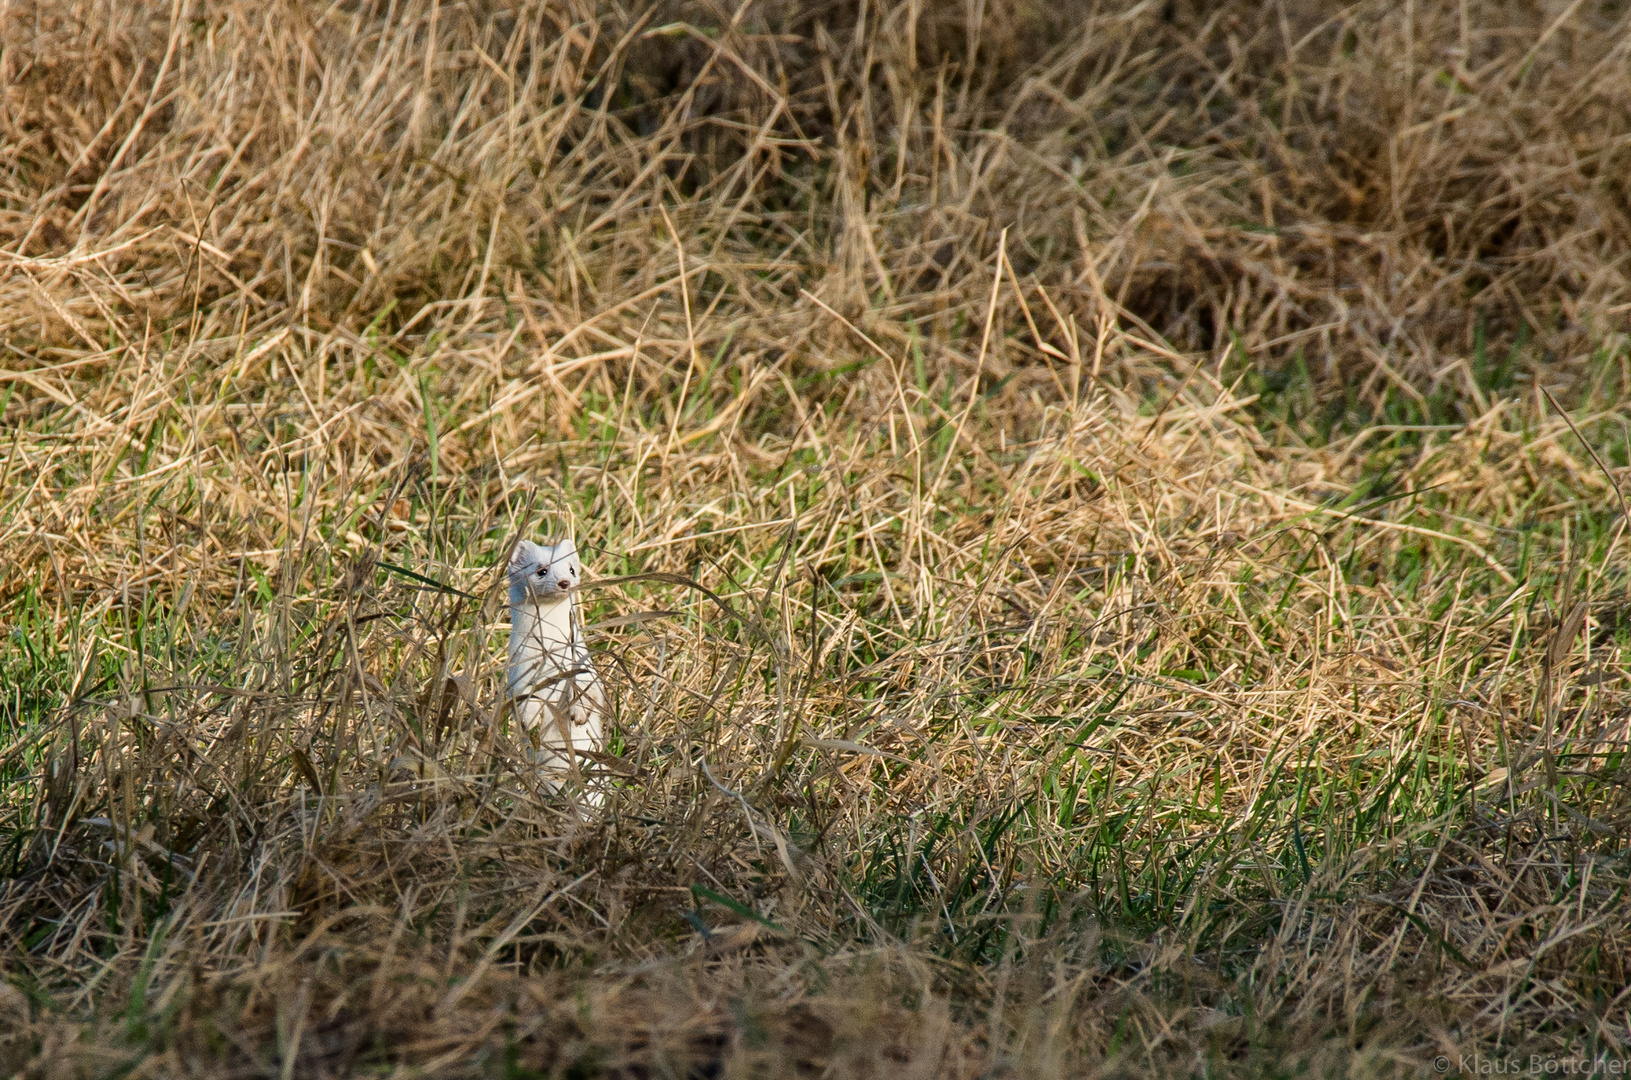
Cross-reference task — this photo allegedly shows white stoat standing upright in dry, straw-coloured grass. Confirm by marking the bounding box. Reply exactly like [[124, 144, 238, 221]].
[[509, 540, 605, 806]]
